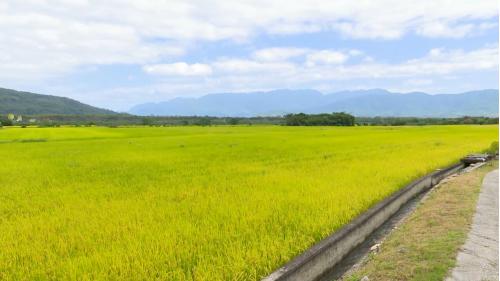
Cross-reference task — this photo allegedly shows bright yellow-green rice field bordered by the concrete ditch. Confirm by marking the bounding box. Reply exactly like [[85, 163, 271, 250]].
[[0, 126, 498, 280]]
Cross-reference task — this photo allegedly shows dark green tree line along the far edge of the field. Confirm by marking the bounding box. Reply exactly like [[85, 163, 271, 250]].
[[0, 112, 498, 127]]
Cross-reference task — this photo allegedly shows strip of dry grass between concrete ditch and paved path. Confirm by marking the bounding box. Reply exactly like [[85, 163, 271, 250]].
[[343, 161, 498, 281]]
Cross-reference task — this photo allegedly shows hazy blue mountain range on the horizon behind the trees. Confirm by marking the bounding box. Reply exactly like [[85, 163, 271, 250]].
[[129, 89, 498, 117]]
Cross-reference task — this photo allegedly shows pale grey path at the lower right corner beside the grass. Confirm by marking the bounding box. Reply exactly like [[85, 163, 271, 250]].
[[446, 170, 498, 281]]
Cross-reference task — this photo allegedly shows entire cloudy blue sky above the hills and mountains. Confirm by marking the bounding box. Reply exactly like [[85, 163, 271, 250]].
[[0, 0, 499, 111]]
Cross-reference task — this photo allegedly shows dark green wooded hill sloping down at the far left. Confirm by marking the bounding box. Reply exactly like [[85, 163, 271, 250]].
[[0, 88, 115, 114]]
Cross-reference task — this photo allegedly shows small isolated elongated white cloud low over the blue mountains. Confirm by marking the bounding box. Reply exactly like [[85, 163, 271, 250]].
[[143, 62, 212, 76]]
